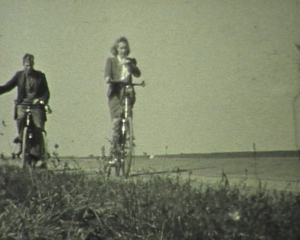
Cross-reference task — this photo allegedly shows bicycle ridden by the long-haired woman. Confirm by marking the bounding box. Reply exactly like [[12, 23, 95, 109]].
[[104, 81, 146, 177]]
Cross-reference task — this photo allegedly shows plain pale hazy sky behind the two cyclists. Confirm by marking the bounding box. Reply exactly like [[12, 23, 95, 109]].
[[0, 0, 300, 156]]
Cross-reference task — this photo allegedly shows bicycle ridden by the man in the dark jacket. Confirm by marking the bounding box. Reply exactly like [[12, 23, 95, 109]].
[[17, 101, 52, 168]]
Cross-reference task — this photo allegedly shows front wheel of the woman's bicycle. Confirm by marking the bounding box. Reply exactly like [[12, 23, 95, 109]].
[[121, 117, 133, 177]]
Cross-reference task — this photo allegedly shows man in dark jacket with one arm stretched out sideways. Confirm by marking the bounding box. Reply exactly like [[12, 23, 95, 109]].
[[0, 53, 50, 160]]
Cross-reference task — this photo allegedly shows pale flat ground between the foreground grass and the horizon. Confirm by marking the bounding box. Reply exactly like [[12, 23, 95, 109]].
[[2, 157, 300, 192]]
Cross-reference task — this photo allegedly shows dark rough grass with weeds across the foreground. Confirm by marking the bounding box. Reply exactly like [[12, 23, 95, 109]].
[[0, 166, 300, 240]]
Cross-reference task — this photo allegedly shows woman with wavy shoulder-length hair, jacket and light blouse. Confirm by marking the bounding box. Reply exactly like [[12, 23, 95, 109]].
[[104, 37, 141, 164]]
